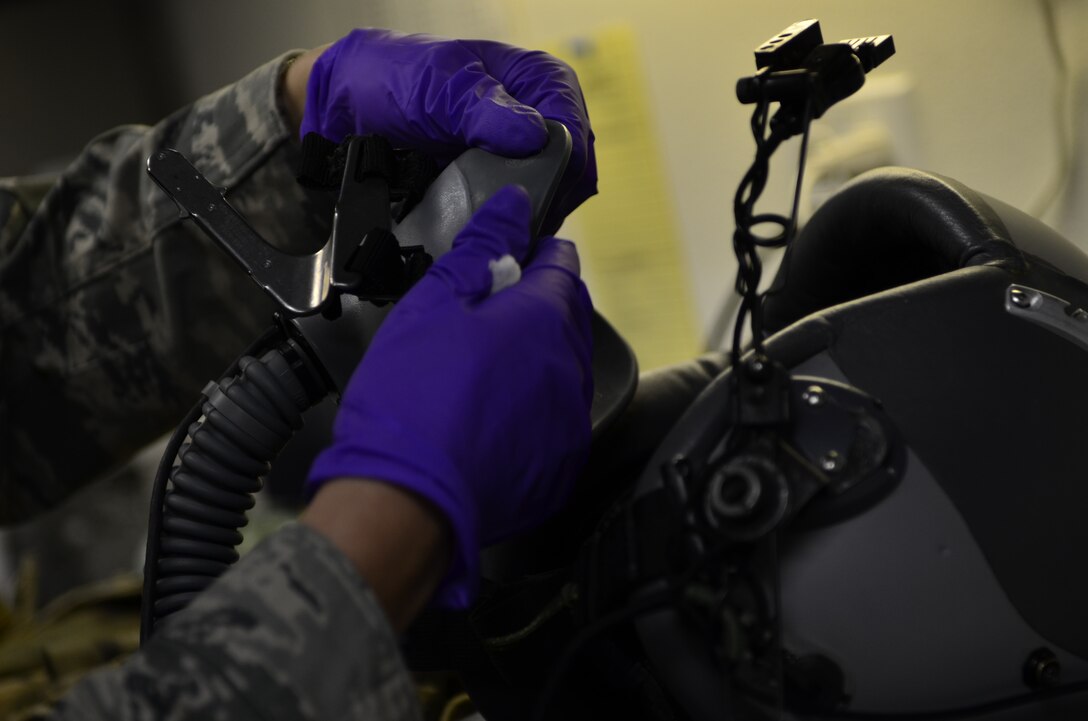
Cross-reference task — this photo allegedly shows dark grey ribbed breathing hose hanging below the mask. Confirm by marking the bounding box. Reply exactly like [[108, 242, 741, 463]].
[[140, 341, 324, 642]]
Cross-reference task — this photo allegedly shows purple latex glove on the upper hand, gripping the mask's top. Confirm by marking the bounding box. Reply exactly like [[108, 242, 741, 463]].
[[300, 28, 597, 233]]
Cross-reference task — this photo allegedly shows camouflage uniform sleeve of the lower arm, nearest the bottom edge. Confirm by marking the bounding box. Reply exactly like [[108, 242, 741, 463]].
[[54, 525, 421, 721]]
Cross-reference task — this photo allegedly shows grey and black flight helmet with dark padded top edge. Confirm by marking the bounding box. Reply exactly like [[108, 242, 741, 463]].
[[409, 169, 1088, 721]]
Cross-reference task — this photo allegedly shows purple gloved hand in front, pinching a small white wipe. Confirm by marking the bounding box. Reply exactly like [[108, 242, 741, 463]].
[[309, 186, 593, 608]]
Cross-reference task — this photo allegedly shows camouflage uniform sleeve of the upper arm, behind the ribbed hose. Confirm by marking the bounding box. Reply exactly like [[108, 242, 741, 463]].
[[0, 54, 332, 522]]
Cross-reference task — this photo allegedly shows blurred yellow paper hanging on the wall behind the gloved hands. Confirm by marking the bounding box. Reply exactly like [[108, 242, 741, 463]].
[[546, 26, 700, 370]]
